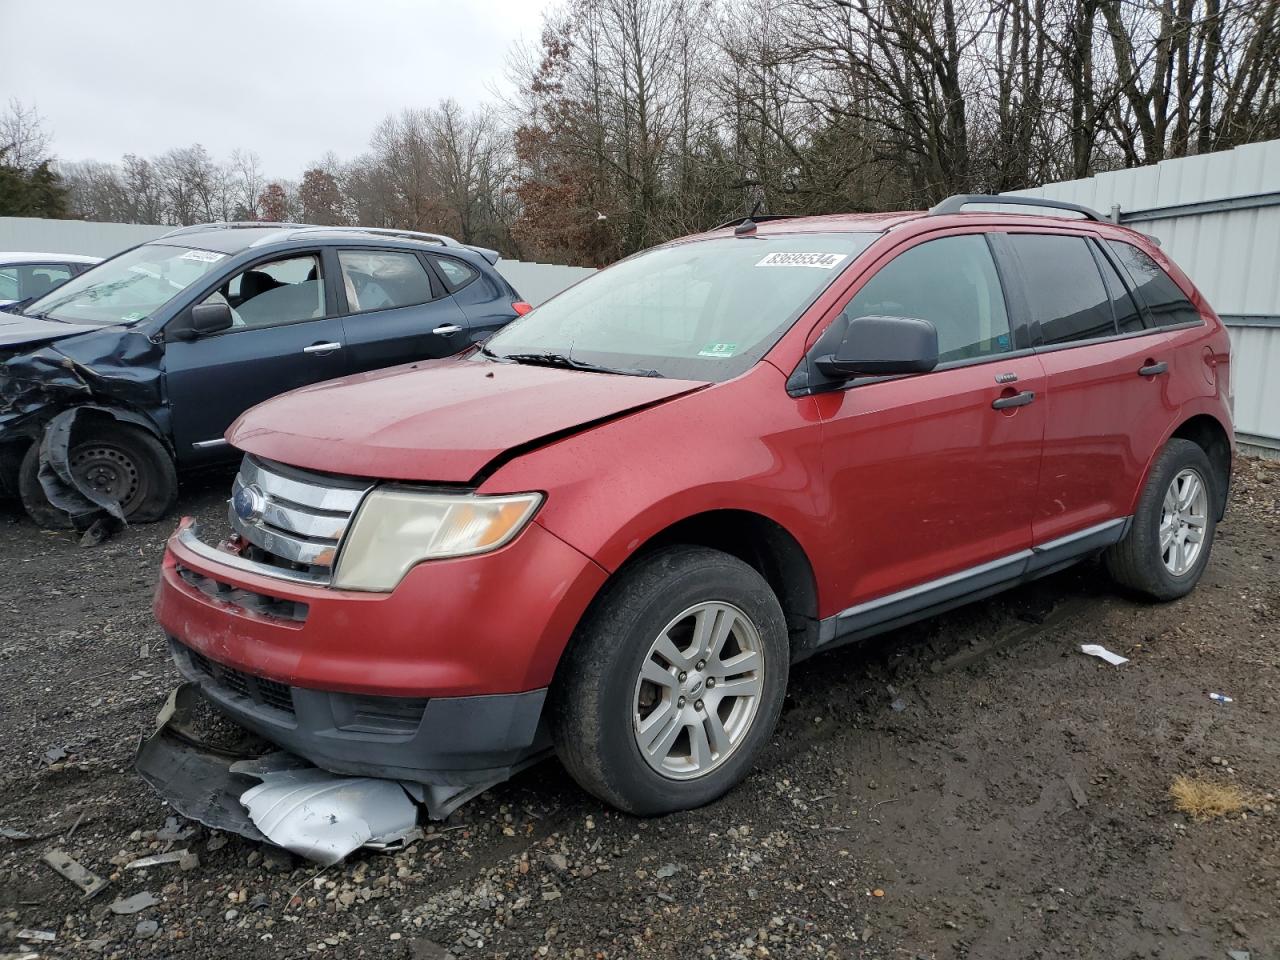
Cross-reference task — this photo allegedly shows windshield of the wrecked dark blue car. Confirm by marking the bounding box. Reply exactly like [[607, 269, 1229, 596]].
[[22, 243, 227, 325]]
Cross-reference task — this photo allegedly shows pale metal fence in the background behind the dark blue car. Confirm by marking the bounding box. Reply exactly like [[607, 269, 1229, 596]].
[[0, 216, 595, 305]]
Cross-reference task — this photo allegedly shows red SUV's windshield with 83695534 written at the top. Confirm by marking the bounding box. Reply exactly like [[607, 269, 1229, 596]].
[[485, 233, 876, 381]]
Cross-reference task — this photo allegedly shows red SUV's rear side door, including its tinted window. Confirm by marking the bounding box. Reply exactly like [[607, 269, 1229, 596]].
[[1009, 233, 1171, 544]]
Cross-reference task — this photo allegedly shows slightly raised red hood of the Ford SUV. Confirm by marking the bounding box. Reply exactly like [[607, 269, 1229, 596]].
[[227, 358, 704, 484]]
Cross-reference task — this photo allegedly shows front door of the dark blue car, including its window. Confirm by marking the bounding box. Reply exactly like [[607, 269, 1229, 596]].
[[164, 245, 347, 463]]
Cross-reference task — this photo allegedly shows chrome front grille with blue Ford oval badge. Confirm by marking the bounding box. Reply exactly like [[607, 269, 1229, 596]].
[[228, 456, 372, 579]]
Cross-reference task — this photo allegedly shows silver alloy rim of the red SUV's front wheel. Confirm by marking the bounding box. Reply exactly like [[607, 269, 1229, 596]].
[[632, 600, 765, 780]]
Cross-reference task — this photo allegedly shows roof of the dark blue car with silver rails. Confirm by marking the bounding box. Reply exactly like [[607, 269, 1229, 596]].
[[150, 220, 498, 264]]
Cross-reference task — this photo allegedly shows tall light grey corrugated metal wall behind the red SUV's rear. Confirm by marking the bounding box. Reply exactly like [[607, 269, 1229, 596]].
[[1015, 140, 1280, 451]]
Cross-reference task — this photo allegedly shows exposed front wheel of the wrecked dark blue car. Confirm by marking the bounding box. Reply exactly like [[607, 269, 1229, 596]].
[[18, 421, 178, 530]]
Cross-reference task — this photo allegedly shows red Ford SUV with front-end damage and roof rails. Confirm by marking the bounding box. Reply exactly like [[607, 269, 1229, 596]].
[[155, 196, 1233, 814]]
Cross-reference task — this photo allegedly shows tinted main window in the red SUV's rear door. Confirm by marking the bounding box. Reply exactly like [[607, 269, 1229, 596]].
[[1009, 233, 1116, 344]]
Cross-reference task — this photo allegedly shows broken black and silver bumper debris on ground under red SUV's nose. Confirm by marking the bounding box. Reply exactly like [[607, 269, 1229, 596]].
[[134, 684, 542, 864]]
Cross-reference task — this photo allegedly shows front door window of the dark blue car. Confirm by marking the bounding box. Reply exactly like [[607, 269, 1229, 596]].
[[204, 253, 325, 330]]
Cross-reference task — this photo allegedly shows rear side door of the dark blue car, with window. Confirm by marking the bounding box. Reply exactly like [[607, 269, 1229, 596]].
[[335, 247, 471, 372]]
